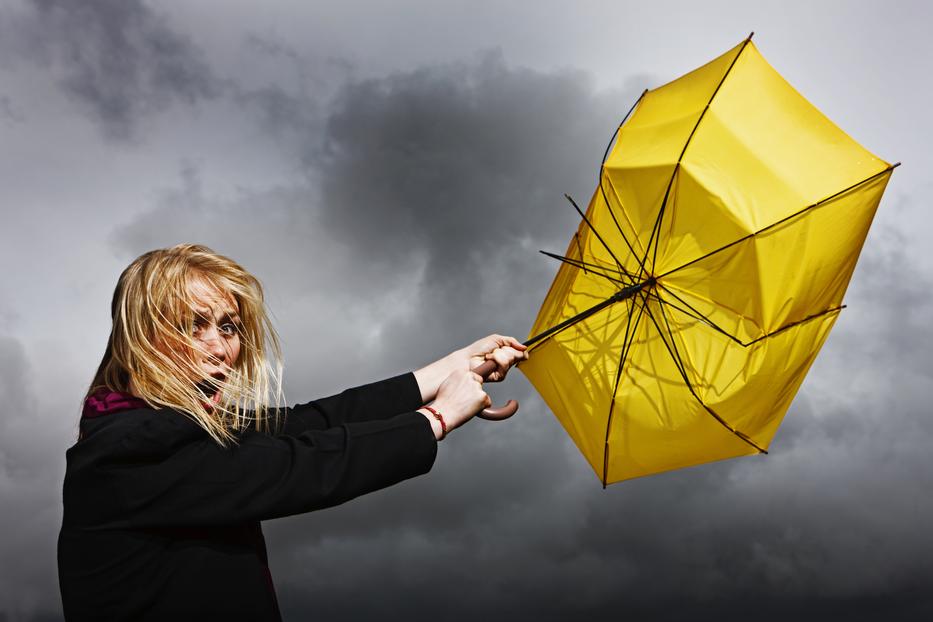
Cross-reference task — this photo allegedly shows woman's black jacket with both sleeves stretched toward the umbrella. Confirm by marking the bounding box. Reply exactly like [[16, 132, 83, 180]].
[[58, 374, 437, 621]]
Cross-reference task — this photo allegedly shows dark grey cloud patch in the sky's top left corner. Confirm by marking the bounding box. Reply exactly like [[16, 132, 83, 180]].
[[6, 0, 220, 139]]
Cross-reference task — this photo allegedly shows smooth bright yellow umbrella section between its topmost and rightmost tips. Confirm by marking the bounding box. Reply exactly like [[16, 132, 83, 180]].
[[684, 43, 888, 231]]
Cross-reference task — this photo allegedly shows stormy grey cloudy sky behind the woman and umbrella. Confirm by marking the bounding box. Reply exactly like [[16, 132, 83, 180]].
[[0, 0, 933, 621]]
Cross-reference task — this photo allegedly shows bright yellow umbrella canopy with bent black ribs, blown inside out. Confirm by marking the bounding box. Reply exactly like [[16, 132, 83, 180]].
[[521, 37, 897, 485]]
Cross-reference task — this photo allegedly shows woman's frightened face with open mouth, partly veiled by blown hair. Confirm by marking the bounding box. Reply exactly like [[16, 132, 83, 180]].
[[188, 279, 240, 404]]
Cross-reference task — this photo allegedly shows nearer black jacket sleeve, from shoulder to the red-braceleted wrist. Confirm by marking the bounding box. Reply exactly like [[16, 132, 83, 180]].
[[65, 411, 437, 529]]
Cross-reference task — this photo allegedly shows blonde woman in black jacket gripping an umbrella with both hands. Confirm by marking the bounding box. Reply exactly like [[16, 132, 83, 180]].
[[58, 245, 527, 620]]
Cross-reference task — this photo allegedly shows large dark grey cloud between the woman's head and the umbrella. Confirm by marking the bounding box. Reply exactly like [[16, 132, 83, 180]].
[[318, 53, 637, 346]]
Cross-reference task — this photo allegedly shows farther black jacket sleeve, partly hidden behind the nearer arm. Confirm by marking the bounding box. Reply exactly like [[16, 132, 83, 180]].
[[280, 372, 424, 436]]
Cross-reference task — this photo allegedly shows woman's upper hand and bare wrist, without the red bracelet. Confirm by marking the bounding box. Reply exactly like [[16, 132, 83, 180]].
[[415, 335, 528, 404]]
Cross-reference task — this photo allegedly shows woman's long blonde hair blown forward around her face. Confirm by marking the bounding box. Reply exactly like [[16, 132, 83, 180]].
[[87, 244, 283, 445]]
